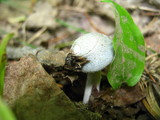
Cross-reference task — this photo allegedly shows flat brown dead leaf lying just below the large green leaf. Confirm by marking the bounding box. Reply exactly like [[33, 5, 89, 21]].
[[101, 84, 146, 107]]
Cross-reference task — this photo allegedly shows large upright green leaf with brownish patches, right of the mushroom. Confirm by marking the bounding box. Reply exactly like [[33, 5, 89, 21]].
[[102, 0, 145, 89]]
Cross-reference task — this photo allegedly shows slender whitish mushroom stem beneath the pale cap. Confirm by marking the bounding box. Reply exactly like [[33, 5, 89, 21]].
[[83, 71, 101, 104]]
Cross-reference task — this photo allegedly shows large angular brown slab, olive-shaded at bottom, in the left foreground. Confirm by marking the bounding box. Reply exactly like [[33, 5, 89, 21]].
[[4, 55, 88, 120]]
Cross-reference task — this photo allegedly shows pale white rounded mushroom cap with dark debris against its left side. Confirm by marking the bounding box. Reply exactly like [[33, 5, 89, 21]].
[[71, 33, 114, 73]]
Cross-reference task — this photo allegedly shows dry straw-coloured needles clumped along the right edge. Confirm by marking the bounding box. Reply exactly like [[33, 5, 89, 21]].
[[142, 53, 160, 120]]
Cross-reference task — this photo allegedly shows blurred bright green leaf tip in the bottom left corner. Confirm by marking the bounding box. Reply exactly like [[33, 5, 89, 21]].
[[0, 98, 16, 120]]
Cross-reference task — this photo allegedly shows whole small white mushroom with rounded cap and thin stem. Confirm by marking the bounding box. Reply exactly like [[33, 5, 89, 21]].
[[71, 33, 114, 103]]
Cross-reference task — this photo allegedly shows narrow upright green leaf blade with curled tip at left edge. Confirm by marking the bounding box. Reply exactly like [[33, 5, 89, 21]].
[[0, 33, 13, 96]]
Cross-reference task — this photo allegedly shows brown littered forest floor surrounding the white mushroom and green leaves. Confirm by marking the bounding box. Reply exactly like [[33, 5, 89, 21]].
[[0, 0, 160, 120]]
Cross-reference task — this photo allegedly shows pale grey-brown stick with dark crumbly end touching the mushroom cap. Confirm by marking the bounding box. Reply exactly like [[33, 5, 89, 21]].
[[7, 46, 88, 72]]
